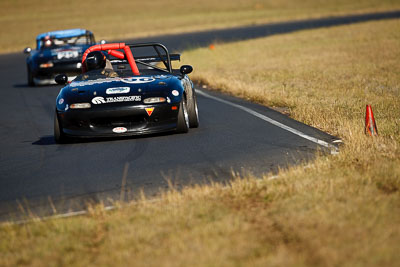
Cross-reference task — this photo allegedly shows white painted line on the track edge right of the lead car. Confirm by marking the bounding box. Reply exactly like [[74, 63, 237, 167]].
[[196, 89, 338, 154]]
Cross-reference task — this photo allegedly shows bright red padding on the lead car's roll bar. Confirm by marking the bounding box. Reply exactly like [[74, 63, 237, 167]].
[[82, 43, 140, 75]]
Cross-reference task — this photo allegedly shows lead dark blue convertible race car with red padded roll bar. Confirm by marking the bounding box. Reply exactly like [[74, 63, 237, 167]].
[[54, 43, 199, 143]]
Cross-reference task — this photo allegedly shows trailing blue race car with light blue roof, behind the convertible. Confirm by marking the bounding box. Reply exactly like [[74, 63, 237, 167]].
[[24, 29, 99, 86]]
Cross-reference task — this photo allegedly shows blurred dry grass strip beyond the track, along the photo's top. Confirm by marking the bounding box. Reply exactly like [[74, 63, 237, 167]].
[[0, 0, 400, 53]]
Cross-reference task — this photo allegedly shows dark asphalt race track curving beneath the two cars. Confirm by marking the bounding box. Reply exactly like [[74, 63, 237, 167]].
[[0, 11, 400, 221]]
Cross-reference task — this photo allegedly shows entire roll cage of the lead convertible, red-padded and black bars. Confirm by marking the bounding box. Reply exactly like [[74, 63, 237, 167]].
[[82, 43, 180, 76]]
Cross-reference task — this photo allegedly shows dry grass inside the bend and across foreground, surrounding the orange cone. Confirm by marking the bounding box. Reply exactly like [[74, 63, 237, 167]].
[[0, 20, 400, 266]]
